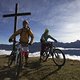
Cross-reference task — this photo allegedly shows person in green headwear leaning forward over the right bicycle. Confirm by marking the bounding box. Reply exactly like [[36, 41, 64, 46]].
[[40, 28, 57, 58]]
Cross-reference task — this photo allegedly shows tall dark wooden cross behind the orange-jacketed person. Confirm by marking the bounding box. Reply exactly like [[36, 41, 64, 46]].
[[3, 3, 31, 50]]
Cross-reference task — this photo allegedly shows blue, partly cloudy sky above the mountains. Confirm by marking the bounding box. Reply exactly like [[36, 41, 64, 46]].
[[0, 0, 80, 44]]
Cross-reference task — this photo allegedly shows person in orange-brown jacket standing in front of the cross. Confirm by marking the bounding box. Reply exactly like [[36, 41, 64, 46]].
[[9, 20, 34, 65]]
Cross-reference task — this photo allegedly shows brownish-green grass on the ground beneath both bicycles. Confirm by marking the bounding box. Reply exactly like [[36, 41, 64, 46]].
[[0, 56, 80, 80]]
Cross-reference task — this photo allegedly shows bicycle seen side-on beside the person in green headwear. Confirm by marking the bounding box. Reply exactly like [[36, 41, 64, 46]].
[[40, 42, 66, 66]]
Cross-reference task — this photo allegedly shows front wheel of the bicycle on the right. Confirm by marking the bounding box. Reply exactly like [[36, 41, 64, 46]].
[[52, 49, 66, 66]]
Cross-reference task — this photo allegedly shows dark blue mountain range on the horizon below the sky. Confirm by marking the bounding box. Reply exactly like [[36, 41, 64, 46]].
[[0, 40, 80, 52]]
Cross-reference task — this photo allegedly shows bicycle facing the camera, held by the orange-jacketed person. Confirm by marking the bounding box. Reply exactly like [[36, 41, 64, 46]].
[[8, 41, 29, 76]]
